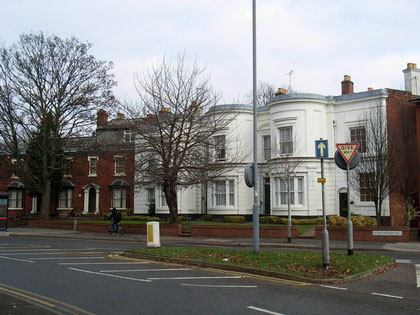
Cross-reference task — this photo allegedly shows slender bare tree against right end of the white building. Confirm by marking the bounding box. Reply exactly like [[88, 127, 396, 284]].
[[350, 105, 396, 225]]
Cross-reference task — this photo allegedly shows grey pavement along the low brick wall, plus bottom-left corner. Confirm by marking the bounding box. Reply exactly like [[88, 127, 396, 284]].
[[0, 227, 420, 314]]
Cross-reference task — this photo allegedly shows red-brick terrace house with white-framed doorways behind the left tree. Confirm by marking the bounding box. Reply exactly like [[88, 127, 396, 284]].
[[0, 109, 134, 218]]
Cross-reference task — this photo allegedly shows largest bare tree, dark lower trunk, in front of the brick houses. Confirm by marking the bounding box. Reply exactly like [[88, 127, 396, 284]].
[[0, 33, 116, 219]]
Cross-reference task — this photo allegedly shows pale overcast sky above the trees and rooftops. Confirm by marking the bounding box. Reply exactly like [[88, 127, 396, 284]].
[[0, 0, 420, 103]]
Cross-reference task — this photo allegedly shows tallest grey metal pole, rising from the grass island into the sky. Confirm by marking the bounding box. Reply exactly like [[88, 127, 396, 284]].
[[252, 0, 260, 252]]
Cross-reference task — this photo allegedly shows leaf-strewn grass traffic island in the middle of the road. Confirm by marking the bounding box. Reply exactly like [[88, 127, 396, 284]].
[[127, 247, 392, 279]]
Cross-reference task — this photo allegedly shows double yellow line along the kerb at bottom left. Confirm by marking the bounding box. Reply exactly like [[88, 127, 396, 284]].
[[0, 283, 93, 315]]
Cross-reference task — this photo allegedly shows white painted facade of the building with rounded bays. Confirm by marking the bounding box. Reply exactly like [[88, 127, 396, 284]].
[[134, 90, 389, 217]]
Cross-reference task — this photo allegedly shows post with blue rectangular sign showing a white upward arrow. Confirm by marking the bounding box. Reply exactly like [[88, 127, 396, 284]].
[[315, 139, 330, 269]]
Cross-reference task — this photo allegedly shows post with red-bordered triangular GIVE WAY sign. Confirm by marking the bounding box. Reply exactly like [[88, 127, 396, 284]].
[[336, 143, 359, 256]]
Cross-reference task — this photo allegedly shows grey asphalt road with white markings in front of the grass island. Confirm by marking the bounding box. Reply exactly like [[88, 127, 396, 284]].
[[0, 237, 420, 314]]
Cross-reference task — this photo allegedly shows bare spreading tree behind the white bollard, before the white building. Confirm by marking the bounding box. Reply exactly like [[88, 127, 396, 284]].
[[126, 57, 243, 223]]
